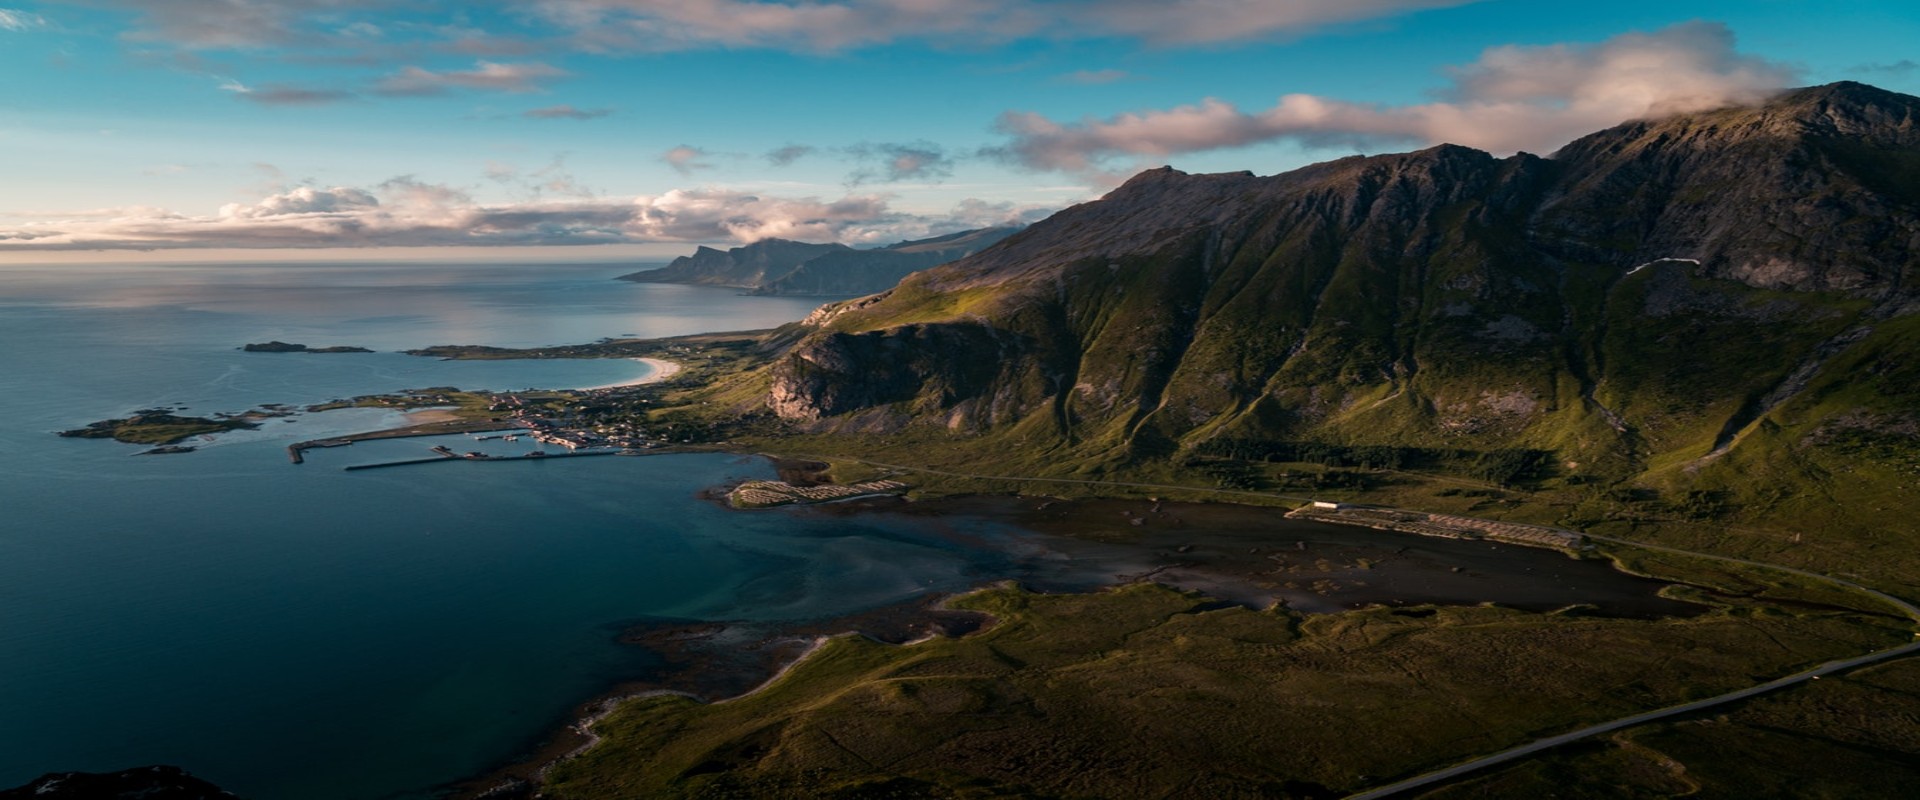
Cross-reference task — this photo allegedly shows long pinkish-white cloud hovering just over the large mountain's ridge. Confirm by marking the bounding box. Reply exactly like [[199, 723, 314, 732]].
[[991, 21, 1795, 171]]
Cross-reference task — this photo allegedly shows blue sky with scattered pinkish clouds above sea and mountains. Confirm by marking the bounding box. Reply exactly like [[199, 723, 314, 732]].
[[0, 0, 1920, 263]]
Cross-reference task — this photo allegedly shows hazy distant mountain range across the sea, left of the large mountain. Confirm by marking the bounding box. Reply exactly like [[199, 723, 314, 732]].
[[620, 228, 1020, 295]]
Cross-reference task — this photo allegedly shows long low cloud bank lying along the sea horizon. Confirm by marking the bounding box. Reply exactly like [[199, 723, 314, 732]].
[[0, 176, 1052, 253]]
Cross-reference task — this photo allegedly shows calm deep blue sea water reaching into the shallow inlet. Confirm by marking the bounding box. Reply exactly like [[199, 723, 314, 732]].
[[0, 258, 1689, 800]]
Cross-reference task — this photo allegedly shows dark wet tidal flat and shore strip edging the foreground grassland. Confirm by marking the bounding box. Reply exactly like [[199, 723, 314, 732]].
[[451, 495, 1707, 800]]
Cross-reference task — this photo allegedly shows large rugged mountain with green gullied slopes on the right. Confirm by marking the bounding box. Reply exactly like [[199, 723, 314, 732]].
[[770, 84, 1920, 473]]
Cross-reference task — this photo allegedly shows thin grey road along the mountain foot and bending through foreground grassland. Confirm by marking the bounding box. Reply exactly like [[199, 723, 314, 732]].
[[798, 457, 1920, 800]]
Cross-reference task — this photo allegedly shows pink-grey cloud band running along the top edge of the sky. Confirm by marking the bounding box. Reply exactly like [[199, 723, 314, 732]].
[[60, 0, 1482, 56]]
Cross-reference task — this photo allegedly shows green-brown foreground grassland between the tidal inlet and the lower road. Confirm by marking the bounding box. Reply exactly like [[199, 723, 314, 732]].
[[545, 585, 1910, 798]]
